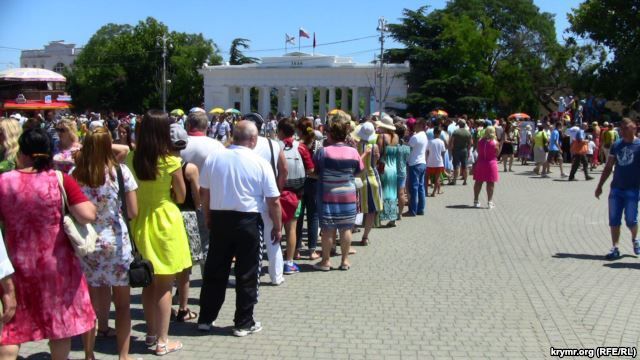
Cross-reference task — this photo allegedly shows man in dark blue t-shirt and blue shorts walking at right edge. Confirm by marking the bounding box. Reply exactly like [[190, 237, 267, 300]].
[[595, 118, 640, 260]]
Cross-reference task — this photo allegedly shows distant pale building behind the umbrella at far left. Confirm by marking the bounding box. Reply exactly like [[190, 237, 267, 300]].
[[20, 40, 82, 74]]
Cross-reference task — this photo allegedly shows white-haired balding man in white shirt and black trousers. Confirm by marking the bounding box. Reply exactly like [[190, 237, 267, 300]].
[[198, 121, 282, 336]]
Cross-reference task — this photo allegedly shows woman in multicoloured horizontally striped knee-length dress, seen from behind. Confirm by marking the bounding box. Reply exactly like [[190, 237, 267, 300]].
[[314, 112, 364, 271]]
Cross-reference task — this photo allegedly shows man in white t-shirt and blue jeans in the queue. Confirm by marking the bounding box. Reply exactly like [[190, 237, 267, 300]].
[[402, 118, 429, 216]]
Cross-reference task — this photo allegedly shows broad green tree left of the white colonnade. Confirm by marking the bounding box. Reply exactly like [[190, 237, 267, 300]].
[[66, 18, 222, 112]]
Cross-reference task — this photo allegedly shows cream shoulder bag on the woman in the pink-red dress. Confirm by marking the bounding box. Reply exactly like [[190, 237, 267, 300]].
[[56, 170, 98, 257]]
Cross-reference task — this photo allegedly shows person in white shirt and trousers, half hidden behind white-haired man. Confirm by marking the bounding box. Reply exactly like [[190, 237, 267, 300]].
[[244, 113, 287, 285]]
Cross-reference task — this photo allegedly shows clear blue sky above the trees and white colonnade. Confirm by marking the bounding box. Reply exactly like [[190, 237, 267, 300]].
[[0, 0, 580, 69]]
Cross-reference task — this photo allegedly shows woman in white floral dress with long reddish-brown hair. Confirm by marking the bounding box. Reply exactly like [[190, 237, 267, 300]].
[[73, 127, 138, 359]]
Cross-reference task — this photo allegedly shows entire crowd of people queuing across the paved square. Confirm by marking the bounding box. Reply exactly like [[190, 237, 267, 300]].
[[0, 102, 640, 359]]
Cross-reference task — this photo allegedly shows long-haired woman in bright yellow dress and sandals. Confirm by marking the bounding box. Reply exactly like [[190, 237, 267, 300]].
[[129, 110, 191, 355]]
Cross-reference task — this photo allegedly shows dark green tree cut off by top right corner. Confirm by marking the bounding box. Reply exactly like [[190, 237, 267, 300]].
[[568, 0, 640, 104]]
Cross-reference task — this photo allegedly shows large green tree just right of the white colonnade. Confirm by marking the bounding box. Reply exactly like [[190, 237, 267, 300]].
[[387, 0, 563, 116]]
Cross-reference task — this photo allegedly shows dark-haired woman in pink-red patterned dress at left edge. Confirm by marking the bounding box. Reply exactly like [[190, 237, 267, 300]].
[[0, 129, 96, 360]]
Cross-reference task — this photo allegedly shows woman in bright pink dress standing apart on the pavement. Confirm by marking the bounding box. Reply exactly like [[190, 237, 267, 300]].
[[473, 126, 500, 209]]
